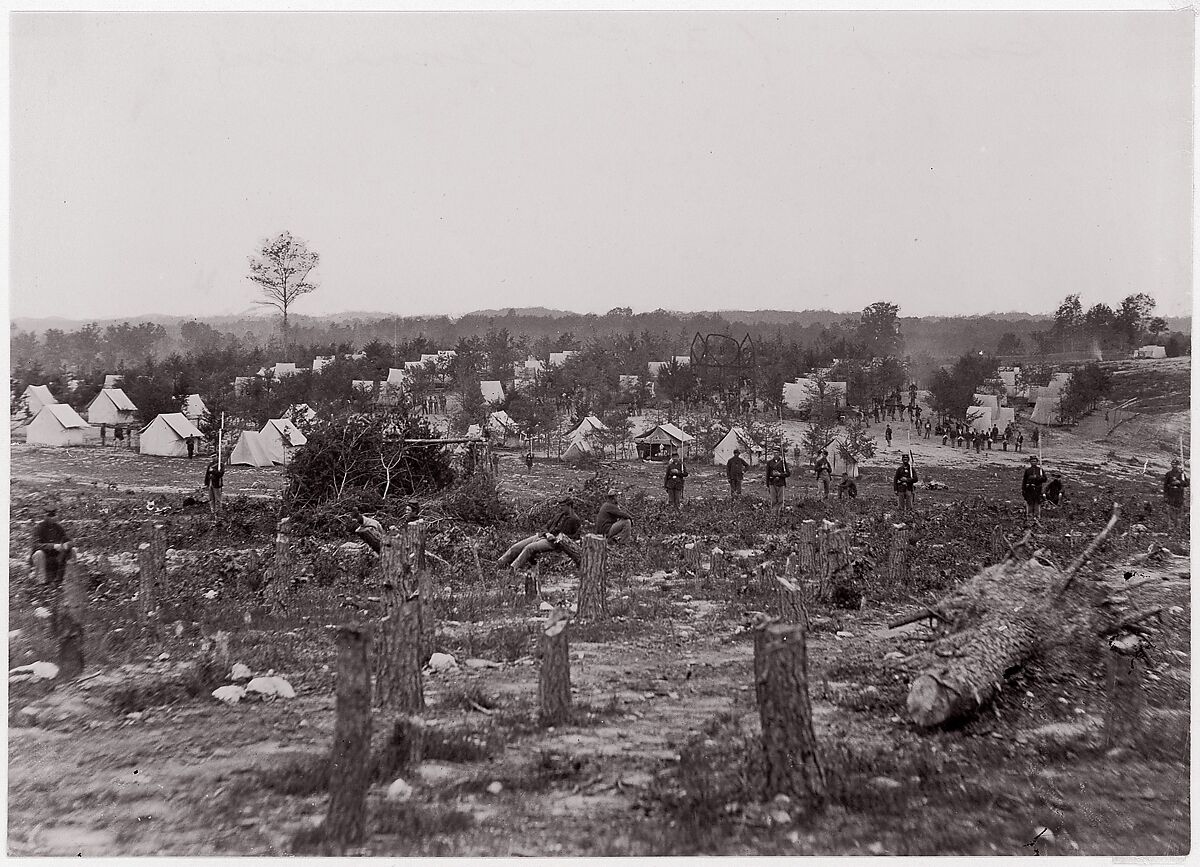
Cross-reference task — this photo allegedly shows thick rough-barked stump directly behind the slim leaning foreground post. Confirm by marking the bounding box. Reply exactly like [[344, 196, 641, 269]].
[[374, 547, 425, 713]]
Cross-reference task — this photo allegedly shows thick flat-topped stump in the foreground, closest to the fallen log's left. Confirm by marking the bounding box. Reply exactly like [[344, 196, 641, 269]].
[[755, 623, 826, 806]]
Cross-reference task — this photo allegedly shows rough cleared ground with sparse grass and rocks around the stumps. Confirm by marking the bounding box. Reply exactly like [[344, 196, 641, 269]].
[[8, 389, 1190, 856]]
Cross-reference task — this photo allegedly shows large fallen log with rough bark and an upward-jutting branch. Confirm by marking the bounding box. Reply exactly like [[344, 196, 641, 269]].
[[907, 507, 1120, 727]]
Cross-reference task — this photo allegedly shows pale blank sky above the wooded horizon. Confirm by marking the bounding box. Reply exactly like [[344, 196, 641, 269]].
[[11, 10, 1194, 317]]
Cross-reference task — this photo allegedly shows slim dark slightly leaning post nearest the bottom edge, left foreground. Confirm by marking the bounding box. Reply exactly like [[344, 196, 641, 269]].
[[324, 624, 371, 850]]
